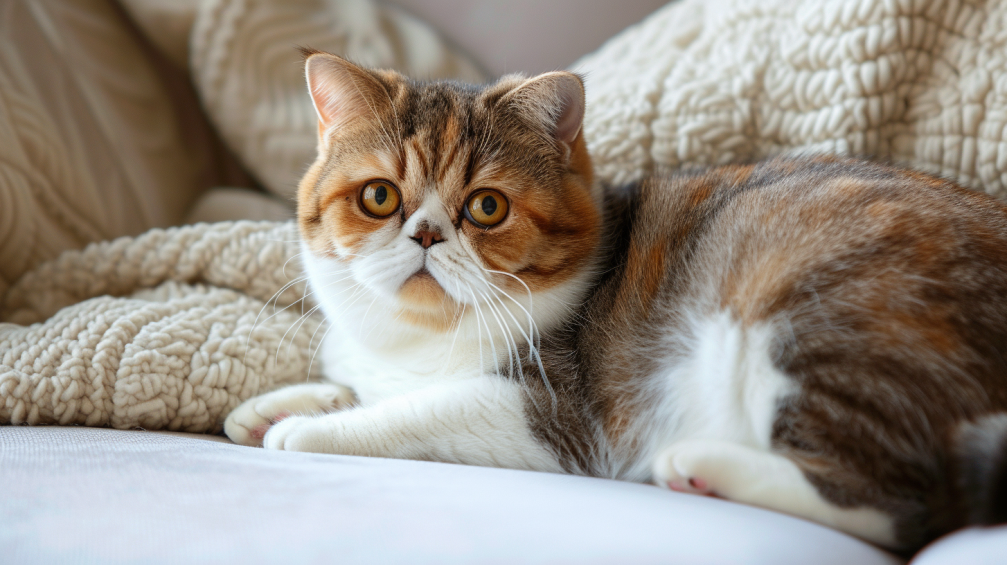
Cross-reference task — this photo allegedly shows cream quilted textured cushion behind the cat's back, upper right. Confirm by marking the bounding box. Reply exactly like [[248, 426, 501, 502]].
[[574, 0, 1007, 196]]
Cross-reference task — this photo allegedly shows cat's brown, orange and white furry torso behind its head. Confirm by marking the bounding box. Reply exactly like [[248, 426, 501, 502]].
[[547, 157, 1007, 541]]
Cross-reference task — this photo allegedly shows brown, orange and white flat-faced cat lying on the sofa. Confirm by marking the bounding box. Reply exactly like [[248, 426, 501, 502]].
[[225, 51, 1007, 550]]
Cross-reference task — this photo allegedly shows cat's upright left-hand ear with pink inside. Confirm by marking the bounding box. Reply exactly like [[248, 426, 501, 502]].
[[304, 51, 388, 135]]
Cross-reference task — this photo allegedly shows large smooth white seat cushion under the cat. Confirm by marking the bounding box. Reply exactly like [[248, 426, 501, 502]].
[[0, 427, 898, 565]]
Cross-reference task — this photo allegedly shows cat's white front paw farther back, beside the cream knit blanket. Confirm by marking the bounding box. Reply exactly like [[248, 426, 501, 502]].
[[224, 383, 354, 445]]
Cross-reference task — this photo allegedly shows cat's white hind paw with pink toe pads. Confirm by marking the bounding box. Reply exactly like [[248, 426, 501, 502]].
[[654, 440, 735, 498]]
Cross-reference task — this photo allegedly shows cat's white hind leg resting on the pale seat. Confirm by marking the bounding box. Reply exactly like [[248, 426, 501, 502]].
[[654, 439, 895, 546]]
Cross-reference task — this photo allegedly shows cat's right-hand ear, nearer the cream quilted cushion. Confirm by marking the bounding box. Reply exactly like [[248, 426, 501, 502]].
[[508, 70, 584, 156]]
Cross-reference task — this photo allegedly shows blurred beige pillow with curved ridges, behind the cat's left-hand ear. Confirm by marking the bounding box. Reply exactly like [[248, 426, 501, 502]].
[[189, 0, 484, 198]]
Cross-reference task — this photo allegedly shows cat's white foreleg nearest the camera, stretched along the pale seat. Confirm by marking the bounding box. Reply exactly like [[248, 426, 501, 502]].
[[264, 376, 563, 472]]
